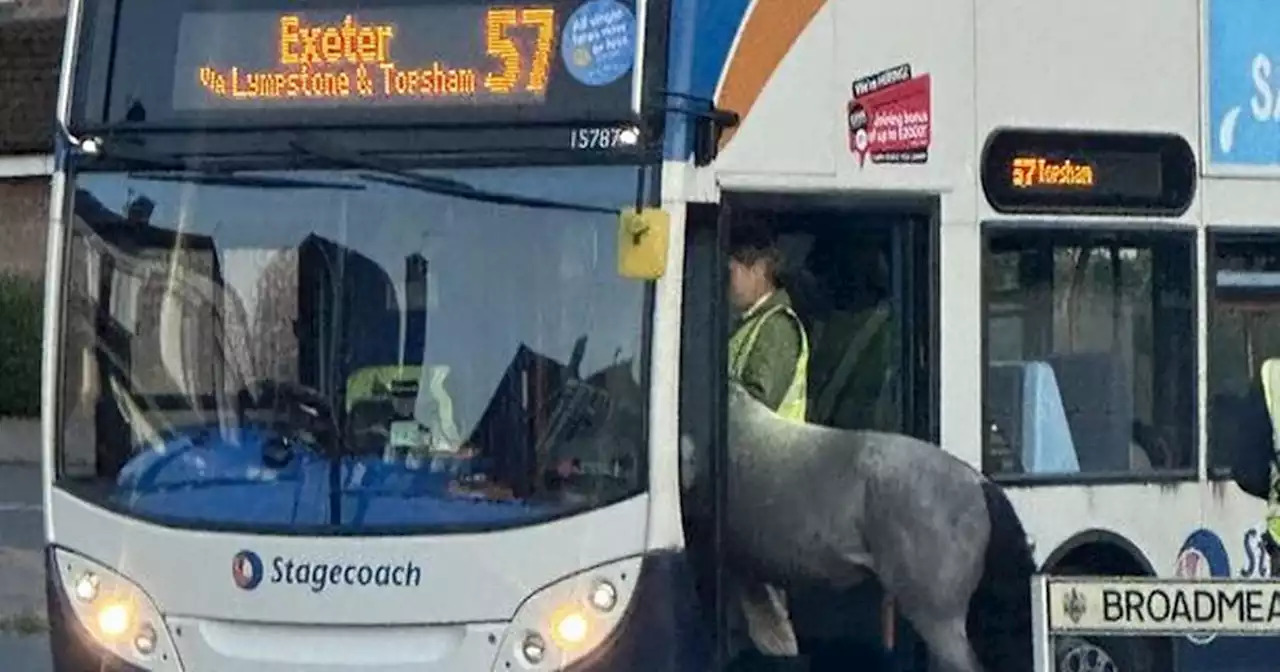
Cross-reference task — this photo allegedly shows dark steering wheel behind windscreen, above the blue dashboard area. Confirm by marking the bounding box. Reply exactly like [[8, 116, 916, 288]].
[[244, 380, 338, 468]]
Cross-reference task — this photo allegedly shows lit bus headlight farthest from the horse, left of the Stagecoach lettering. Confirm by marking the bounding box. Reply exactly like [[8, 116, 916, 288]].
[[54, 548, 182, 672]]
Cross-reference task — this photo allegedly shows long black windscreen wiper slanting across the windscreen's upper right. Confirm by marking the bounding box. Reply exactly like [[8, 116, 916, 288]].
[[289, 137, 618, 215]]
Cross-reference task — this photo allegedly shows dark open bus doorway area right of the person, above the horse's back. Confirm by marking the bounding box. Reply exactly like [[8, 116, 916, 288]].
[[730, 209, 937, 439]]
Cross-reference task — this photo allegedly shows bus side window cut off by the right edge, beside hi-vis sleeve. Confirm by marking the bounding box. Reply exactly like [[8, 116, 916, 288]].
[[1208, 233, 1280, 476]]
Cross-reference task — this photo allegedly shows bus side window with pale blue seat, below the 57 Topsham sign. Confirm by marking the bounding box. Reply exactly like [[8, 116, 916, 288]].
[[983, 227, 1196, 477]]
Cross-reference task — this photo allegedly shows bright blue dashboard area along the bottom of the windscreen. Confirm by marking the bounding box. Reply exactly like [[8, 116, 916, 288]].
[[113, 426, 558, 529]]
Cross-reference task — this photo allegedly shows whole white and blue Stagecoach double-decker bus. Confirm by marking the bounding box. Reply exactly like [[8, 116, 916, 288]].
[[44, 0, 1280, 672]]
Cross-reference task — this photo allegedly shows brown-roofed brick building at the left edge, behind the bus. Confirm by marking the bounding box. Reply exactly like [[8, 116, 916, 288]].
[[0, 0, 65, 278]]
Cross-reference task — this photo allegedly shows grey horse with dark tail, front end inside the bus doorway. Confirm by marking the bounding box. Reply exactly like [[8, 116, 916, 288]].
[[686, 384, 1034, 672]]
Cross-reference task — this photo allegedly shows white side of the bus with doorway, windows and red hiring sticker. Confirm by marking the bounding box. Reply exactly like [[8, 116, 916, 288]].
[[664, 0, 1280, 671]]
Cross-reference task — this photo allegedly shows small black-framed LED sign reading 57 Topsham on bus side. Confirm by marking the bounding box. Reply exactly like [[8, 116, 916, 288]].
[[982, 131, 1196, 215]]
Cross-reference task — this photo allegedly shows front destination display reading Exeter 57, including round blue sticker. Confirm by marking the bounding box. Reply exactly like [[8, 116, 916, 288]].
[[172, 0, 635, 111]]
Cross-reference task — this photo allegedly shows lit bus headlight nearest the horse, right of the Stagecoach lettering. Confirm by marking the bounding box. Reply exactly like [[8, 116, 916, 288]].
[[494, 557, 641, 671]]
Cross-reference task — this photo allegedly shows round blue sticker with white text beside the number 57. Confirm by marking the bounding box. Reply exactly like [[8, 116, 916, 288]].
[[561, 0, 636, 86]]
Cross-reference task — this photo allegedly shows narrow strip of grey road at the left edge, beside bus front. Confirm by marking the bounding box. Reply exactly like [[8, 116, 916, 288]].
[[0, 463, 52, 672]]
